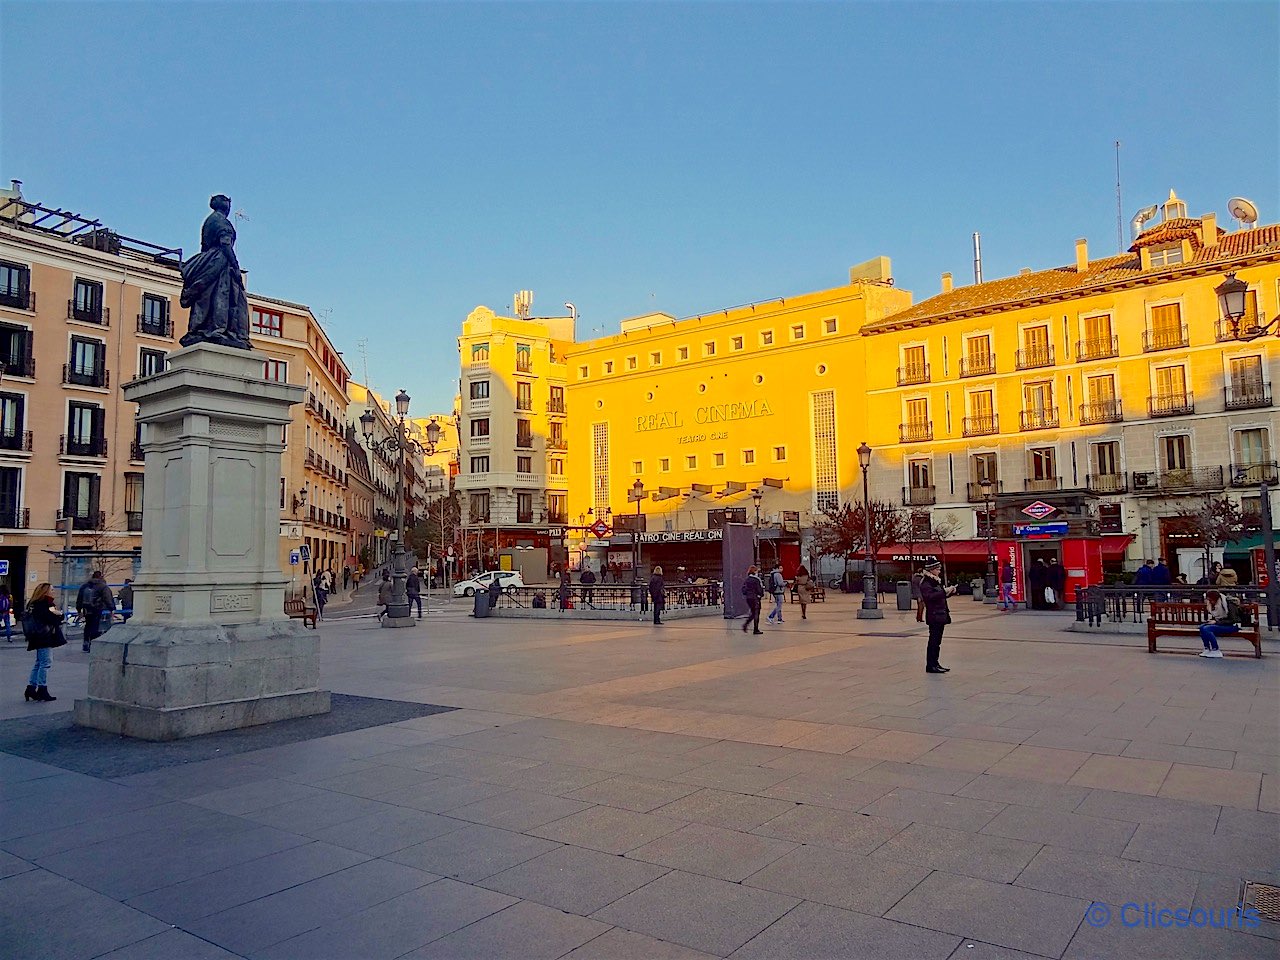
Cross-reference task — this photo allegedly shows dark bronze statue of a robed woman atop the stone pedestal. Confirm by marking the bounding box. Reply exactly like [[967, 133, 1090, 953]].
[[179, 193, 253, 349]]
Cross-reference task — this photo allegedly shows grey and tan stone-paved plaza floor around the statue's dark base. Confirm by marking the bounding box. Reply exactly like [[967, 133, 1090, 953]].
[[0, 596, 1280, 960]]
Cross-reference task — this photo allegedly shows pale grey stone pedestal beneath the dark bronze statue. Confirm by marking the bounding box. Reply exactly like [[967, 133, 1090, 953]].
[[74, 343, 329, 740]]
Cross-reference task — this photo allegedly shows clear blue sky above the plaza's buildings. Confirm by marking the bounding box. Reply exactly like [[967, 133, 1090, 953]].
[[0, 0, 1280, 413]]
